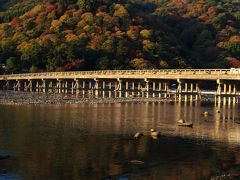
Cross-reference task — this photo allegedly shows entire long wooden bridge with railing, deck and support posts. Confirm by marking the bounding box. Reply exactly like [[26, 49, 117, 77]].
[[0, 68, 240, 103]]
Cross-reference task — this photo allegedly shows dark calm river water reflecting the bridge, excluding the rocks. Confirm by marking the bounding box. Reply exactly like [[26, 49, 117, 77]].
[[0, 103, 240, 180]]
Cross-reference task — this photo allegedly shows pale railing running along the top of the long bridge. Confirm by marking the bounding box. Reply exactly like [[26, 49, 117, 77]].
[[0, 69, 237, 78]]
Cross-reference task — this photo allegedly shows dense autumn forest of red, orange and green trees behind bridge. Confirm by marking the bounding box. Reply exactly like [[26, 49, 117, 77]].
[[0, 0, 240, 73]]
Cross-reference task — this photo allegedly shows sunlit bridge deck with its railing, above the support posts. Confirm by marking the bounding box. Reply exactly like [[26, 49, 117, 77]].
[[0, 69, 240, 80]]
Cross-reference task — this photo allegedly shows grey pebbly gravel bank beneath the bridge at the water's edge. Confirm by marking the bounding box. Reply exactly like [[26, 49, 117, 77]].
[[0, 91, 214, 105]]
